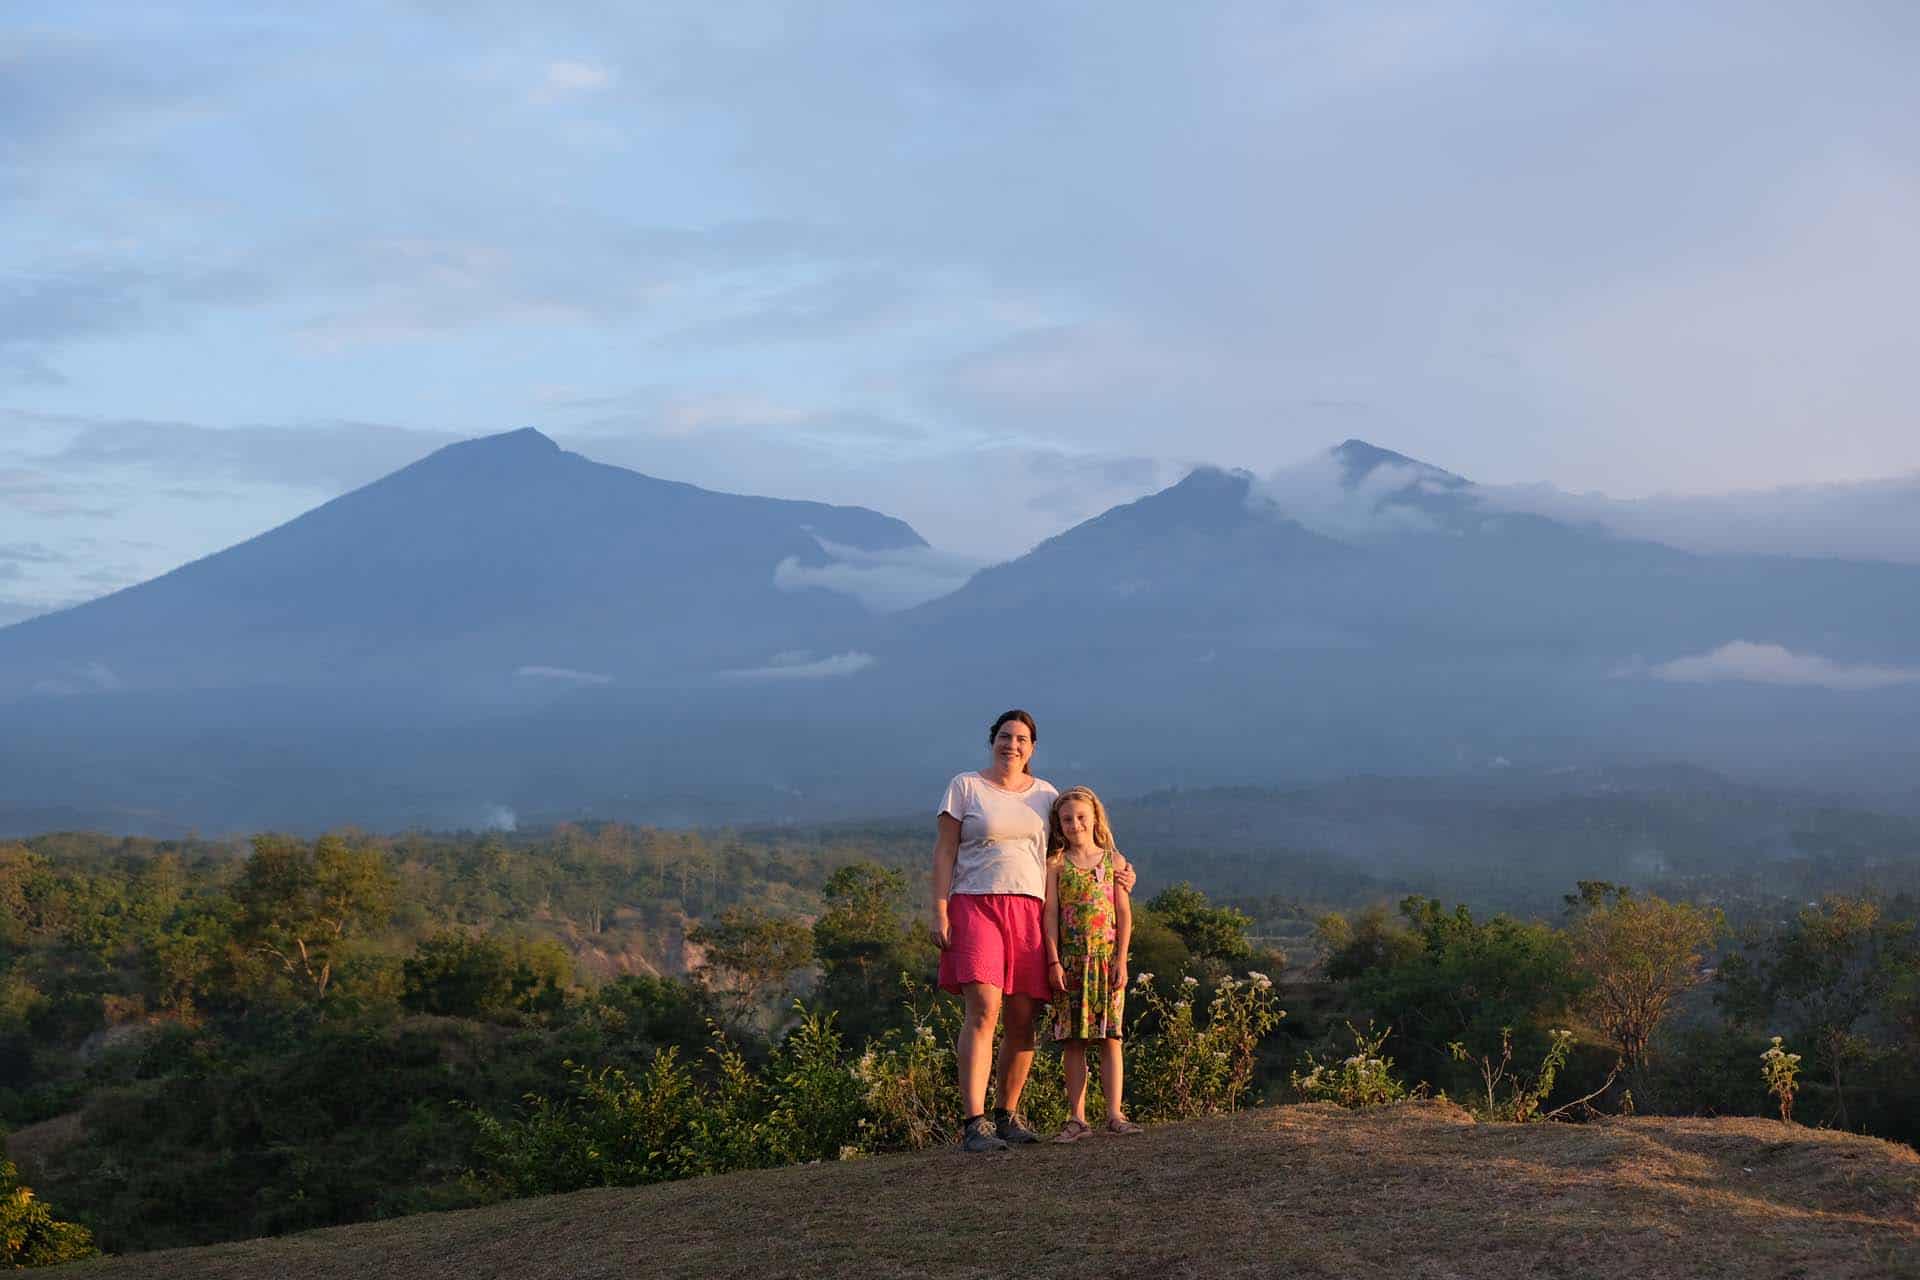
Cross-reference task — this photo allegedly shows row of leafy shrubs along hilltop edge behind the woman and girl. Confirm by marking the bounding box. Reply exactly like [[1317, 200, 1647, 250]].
[[470, 973, 1284, 1196]]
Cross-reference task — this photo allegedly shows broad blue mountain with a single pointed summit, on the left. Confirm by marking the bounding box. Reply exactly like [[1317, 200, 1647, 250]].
[[0, 430, 925, 699]]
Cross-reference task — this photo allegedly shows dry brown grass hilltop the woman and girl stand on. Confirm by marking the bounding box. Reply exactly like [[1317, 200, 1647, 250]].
[[63, 1102, 1920, 1280]]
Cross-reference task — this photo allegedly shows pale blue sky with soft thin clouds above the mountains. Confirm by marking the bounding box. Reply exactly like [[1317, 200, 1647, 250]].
[[0, 0, 1920, 624]]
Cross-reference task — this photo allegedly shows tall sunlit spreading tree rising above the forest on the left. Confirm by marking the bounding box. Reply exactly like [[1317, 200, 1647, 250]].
[[234, 835, 394, 1000]]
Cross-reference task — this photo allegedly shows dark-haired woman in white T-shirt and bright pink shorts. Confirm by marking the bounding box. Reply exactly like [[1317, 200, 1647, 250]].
[[933, 710, 1135, 1151]]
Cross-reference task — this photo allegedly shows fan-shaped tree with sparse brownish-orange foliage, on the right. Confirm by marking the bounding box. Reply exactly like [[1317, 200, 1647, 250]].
[[1567, 881, 1726, 1071]]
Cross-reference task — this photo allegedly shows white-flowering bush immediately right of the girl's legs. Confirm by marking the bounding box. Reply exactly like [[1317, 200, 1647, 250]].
[[1127, 973, 1286, 1121]]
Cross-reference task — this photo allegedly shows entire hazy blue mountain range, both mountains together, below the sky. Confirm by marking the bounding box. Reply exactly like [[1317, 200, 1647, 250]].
[[0, 432, 1920, 831]]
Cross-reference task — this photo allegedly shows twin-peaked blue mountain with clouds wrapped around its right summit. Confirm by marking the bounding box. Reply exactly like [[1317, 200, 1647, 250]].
[[862, 439, 1920, 789]]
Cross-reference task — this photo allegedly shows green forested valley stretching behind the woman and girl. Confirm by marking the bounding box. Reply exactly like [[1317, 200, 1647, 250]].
[[0, 793, 1920, 1261]]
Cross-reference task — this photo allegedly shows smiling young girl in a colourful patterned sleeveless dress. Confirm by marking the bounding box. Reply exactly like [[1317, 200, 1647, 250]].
[[1044, 787, 1140, 1142]]
